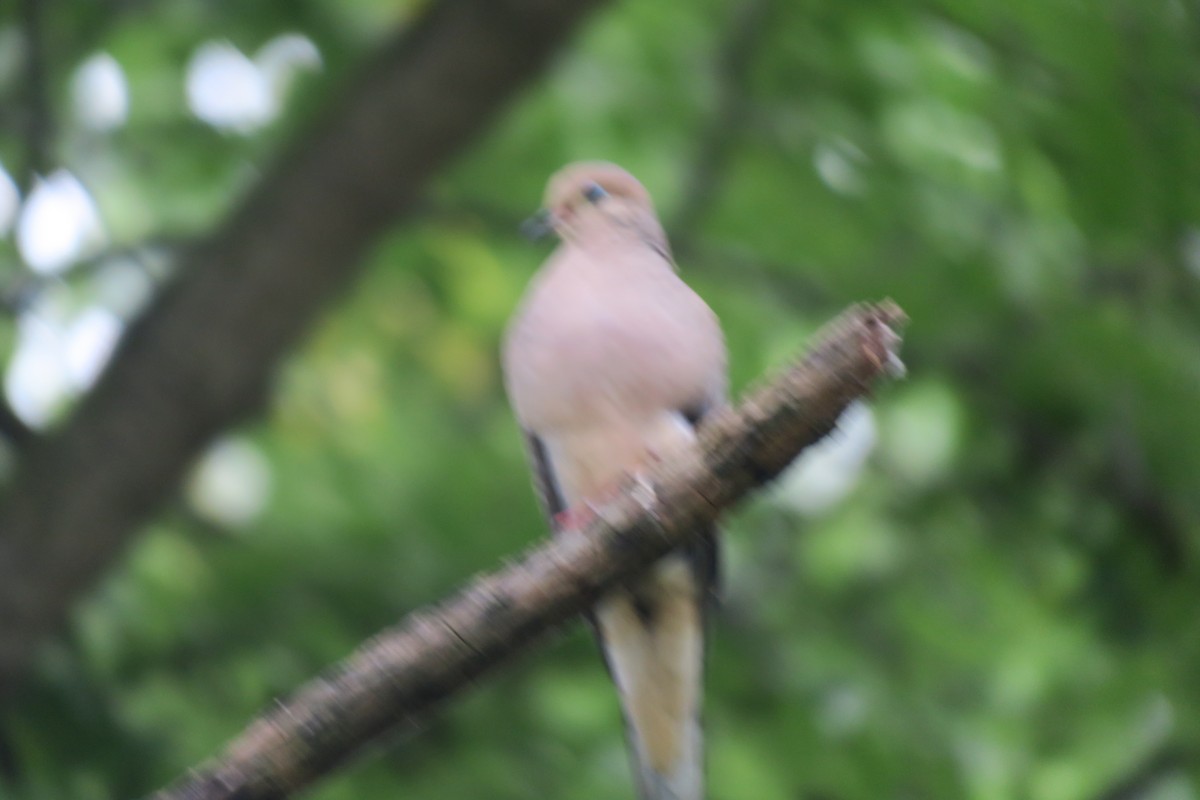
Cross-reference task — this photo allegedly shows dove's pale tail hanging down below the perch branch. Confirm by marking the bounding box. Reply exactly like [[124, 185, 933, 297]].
[[595, 554, 707, 800]]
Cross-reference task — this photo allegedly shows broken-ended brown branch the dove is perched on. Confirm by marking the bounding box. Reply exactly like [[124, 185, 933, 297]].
[[147, 302, 902, 800]]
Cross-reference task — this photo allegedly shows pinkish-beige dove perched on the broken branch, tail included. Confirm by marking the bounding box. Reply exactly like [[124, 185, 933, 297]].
[[502, 162, 728, 800]]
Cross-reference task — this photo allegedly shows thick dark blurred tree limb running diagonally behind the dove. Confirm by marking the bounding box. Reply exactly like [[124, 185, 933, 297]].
[[0, 0, 604, 696]]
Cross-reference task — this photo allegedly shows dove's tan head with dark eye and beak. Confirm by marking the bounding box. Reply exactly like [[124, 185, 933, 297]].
[[523, 161, 661, 240]]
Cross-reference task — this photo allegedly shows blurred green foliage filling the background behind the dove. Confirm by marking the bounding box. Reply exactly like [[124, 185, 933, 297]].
[[0, 0, 1200, 800]]
